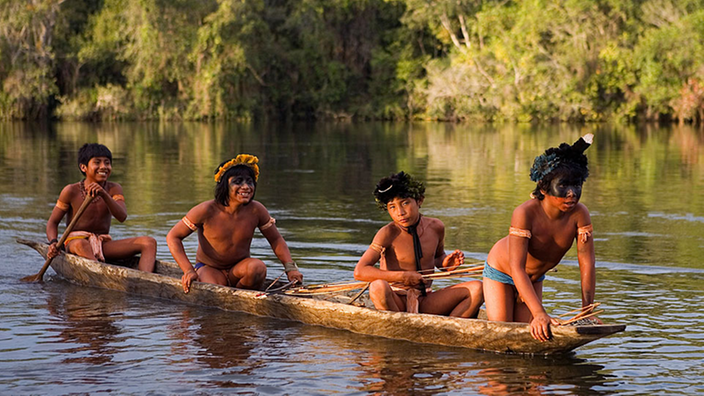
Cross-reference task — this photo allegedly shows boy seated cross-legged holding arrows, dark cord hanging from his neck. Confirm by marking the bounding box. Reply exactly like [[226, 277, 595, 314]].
[[354, 172, 483, 318]]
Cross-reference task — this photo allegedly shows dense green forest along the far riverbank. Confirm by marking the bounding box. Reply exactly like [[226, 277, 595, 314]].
[[0, 0, 704, 123]]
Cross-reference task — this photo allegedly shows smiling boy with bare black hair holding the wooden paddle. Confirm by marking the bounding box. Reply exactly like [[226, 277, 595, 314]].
[[46, 143, 156, 272]]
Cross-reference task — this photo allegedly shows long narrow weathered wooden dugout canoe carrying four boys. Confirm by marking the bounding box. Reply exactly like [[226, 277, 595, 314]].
[[18, 239, 626, 354]]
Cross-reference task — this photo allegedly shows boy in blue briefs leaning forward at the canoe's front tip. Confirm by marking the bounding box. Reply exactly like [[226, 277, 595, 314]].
[[483, 134, 596, 341]]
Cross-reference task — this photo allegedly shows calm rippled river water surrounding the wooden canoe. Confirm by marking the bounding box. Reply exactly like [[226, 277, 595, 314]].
[[0, 123, 704, 395]]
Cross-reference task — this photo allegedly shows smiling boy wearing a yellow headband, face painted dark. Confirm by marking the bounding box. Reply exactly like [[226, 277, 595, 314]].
[[166, 154, 303, 293]]
